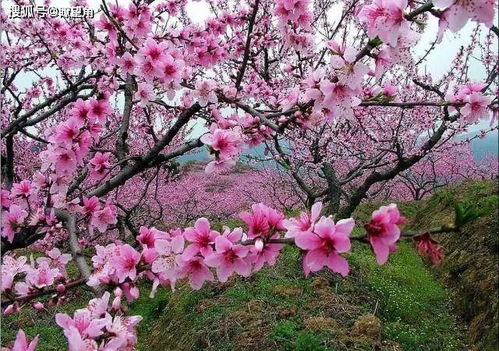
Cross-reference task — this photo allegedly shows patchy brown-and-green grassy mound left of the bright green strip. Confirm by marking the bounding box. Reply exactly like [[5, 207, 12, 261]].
[[139, 247, 366, 350]]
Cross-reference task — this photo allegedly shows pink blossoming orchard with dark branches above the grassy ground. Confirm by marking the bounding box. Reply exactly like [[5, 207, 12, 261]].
[[1, 0, 499, 351]]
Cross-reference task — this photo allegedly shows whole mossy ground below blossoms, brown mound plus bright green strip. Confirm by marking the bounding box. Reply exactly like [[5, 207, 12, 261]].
[[132, 239, 463, 351]]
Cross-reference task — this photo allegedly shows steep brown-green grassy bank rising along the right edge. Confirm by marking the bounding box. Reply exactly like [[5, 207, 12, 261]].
[[412, 181, 499, 351]]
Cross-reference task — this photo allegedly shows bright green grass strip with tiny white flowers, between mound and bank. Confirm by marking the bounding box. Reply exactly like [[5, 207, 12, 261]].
[[350, 243, 462, 351]]
